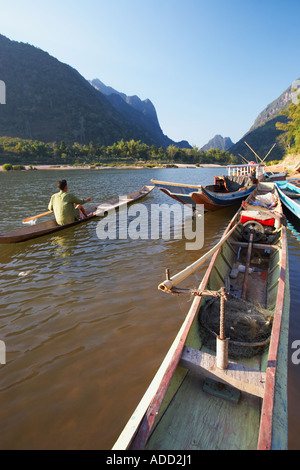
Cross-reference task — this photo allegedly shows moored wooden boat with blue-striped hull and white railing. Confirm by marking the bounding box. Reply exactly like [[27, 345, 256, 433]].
[[151, 163, 265, 211]]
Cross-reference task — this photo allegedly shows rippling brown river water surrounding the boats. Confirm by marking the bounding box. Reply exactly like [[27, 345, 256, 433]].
[[0, 168, 300, 450]]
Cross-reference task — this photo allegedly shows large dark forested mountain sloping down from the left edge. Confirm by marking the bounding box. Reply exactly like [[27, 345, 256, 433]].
[[0, 34, 190, 147]]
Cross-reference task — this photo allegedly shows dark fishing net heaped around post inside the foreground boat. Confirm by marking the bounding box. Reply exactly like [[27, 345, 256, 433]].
[[199, 294, 272, 357]]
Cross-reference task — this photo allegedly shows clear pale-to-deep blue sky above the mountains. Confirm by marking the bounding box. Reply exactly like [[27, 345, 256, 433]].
[[0, 0, 300, 147]]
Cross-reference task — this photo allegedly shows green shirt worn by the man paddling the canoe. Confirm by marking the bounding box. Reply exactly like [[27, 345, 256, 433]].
[[48, 190, 87, 225]]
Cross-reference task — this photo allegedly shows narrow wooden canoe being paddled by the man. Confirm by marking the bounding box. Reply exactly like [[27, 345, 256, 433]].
[[0, 185, 154, 244]]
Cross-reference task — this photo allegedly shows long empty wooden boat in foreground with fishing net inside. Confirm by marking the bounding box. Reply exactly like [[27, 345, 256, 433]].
[[113, 183, 289, 450]]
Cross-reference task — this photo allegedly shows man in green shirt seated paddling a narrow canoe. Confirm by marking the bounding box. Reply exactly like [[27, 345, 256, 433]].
[[48, 180, 91, 225]]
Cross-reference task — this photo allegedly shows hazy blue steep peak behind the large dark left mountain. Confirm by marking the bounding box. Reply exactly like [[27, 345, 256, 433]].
[[90, 78, 192, 148]]
